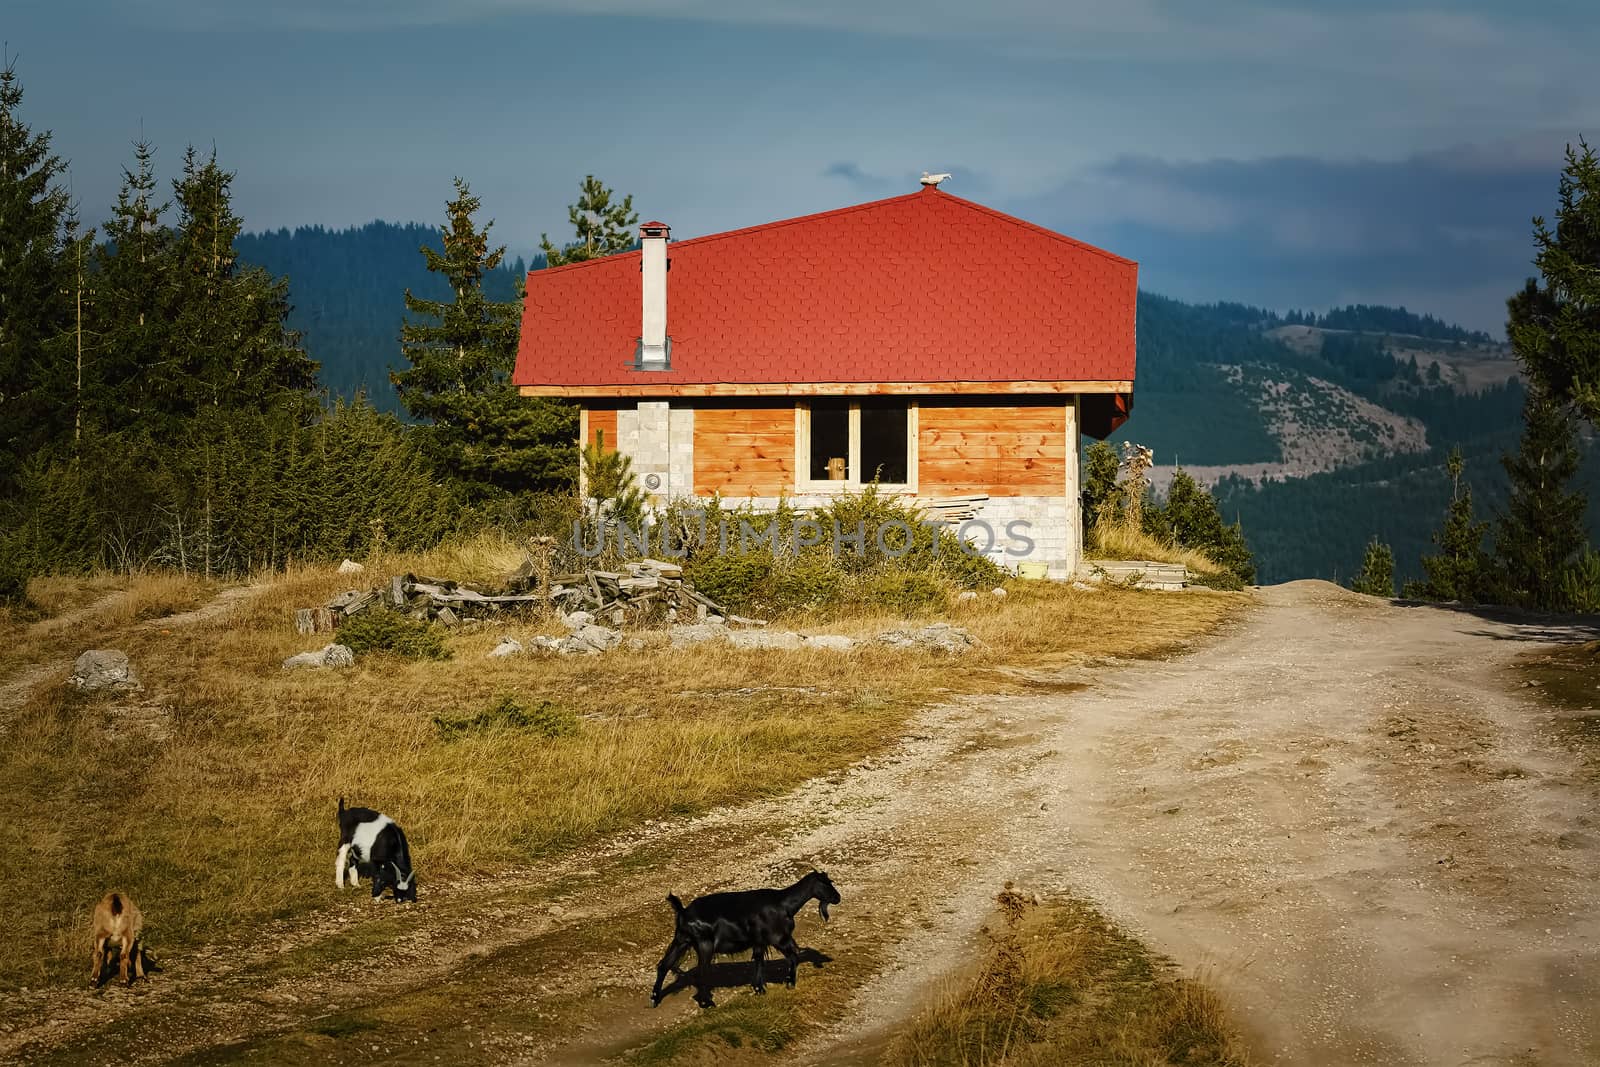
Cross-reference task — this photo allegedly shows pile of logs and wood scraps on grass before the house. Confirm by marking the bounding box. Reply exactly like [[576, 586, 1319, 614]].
[[294, 560, 762, 633]]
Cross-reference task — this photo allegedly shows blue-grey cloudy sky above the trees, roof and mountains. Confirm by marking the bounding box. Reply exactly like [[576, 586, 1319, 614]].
[[0, 0, 1600, 334]]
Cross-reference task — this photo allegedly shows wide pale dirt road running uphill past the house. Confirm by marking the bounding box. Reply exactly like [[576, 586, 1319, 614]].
[[0, 582, 1600, 1064]]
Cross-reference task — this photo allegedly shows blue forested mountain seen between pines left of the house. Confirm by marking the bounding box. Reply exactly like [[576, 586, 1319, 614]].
[[235, 222, 544, 413]]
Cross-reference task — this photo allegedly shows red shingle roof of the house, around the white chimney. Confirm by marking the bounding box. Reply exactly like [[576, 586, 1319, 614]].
[[514, 189, 1138, 394]]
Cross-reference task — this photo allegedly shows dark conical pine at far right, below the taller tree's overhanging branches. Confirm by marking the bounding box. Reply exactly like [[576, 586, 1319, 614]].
[[1494, 387, 1587, 609]]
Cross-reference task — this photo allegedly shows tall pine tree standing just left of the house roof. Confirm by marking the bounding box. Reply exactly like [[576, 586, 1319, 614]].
[[390, 178, 578, 498]]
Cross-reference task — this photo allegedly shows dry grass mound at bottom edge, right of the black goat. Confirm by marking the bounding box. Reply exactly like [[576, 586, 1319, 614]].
[[880, 889, 1248, 1067]]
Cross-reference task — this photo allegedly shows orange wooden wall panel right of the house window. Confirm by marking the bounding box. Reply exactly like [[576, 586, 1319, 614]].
[[917, 400, 1069, 498]]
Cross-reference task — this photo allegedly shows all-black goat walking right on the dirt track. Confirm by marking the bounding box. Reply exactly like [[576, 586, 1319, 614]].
[[650, 870, 838, 1008]]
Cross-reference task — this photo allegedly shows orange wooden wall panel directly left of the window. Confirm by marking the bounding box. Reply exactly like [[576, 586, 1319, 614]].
[[694, 406, 795, 496]]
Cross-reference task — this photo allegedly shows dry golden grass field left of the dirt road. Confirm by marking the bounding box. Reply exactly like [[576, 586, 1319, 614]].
[[0, 544, 1242, 989]]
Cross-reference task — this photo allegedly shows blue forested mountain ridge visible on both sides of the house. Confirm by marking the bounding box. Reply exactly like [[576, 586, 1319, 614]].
[[238, 222, 1574, 582]]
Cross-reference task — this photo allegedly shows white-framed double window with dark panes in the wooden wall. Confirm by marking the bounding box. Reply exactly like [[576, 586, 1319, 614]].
[[795, 400, 917, 493]]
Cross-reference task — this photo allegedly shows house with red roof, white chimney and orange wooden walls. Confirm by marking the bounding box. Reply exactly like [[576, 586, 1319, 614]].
[[515, 177, 1138, 576]]
